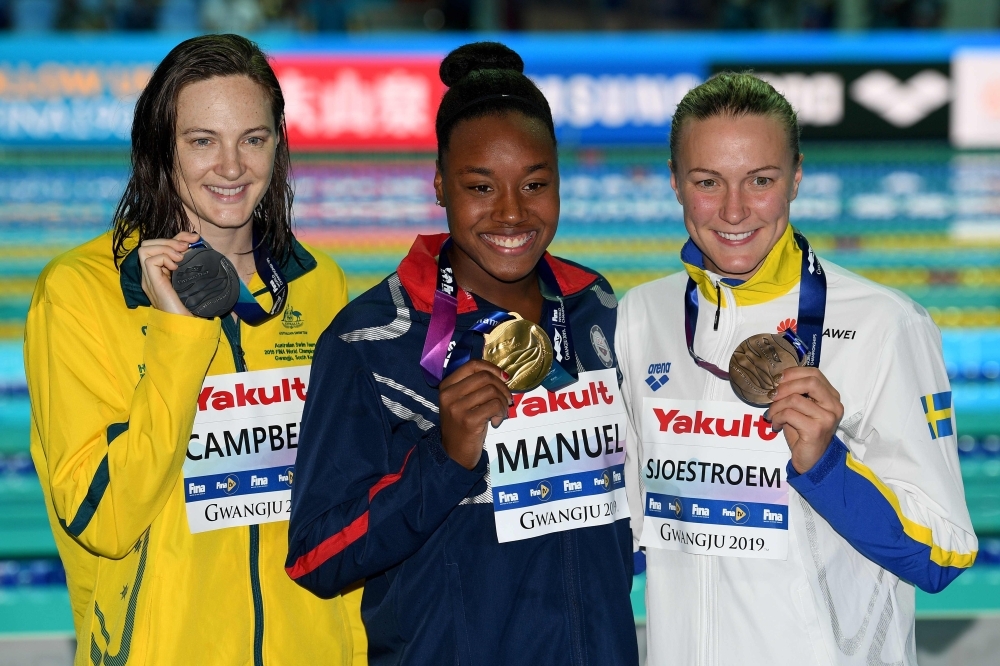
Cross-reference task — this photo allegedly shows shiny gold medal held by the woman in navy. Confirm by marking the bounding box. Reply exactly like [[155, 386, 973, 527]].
[[483, 312, 552, 391]]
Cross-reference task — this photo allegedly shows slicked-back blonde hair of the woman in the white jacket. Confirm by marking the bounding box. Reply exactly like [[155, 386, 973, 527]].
[[670, 72, 799, 163]]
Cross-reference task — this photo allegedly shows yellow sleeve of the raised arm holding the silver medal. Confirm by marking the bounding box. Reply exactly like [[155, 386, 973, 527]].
[[24, 285, 221, 558]]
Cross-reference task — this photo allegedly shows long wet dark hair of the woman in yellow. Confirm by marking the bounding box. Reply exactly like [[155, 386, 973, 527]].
[[112, 35, 292, 263]]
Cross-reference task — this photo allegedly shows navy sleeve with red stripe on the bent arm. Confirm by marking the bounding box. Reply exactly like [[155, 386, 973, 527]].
[[285, 329, 488, 598]]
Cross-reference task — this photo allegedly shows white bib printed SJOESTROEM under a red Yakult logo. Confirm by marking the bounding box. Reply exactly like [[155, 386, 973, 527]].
[[639, 398, 789, 560]]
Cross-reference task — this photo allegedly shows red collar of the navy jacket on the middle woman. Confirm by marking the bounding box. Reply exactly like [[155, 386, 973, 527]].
[[396, 234, 597, 314]]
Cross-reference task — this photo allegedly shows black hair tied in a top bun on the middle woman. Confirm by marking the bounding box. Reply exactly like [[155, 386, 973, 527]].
[[435, 42, 556, 160]]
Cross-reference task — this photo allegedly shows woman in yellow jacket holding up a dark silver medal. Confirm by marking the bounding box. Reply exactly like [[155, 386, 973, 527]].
[[25, 35, 366, 666]]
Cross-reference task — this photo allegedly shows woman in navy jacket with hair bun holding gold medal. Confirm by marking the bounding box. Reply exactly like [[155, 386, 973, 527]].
[[287, 43, 638, 665]]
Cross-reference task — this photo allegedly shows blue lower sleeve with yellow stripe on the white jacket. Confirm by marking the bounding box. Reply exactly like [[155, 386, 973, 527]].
[[787, 437, 975, 592]]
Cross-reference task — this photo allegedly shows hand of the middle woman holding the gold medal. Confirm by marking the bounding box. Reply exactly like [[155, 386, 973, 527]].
[[438, 360, 514, 469]]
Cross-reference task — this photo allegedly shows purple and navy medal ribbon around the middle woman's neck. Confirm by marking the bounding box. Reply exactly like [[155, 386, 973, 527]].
[[420, 238, 577, 391]]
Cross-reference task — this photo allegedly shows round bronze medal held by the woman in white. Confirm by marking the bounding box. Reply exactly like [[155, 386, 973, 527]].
[[729, 333, 806, 407]]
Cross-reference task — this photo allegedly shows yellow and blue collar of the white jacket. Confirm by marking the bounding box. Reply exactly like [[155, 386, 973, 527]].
[[681, 224, 802, 307]]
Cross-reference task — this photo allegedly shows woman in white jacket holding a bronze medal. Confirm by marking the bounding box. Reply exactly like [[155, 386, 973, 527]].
[[616, 73, 977, 666]]
